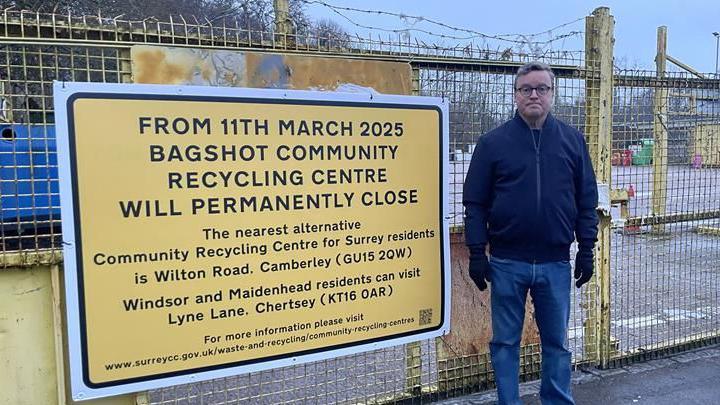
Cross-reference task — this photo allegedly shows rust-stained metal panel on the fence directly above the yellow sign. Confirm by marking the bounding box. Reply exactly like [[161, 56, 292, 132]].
[[131, 45, 412, 94]]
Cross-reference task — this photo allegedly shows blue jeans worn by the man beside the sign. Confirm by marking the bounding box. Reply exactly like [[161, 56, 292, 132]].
[[490, 257, 575, 405]]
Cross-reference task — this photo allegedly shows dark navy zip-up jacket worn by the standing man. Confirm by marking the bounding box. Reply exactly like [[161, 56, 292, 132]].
[[463, 113, 598, 263]]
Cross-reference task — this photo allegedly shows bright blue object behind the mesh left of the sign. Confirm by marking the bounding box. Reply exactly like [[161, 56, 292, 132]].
[[0, 123, 60, 249]]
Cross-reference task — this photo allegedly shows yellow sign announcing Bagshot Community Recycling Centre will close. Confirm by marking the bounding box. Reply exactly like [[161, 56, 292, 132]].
[[59, 86, 449, 398]]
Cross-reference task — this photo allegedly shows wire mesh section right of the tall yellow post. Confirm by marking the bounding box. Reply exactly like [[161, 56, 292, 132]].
[[611, 71, 720, 358]]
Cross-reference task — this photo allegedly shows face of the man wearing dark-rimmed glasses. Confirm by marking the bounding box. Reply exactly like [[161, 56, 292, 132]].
[[515, 70, 553, 122]]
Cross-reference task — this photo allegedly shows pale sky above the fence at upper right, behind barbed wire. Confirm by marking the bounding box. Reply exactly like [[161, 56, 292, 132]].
[[307, 0, 720, 73]]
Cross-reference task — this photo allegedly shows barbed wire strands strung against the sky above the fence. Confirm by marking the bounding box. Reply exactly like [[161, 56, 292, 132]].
[[299, 0, 585, 45]]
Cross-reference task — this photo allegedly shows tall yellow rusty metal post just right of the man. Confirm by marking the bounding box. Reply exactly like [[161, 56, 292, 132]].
[[585, 7, 615, 367]]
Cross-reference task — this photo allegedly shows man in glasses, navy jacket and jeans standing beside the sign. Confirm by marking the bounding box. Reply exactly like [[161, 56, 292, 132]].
[[463, 62, 598, 405]]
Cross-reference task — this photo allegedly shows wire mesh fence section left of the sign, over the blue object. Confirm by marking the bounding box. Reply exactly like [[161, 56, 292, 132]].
[[0, 43, 128, 256]]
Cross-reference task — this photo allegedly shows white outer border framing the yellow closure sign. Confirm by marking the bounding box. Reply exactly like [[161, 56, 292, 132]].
[[53, 81, 452, 401]]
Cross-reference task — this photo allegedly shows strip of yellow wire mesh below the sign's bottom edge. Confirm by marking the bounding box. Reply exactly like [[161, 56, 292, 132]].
[[149, 340, 438, 405]]
